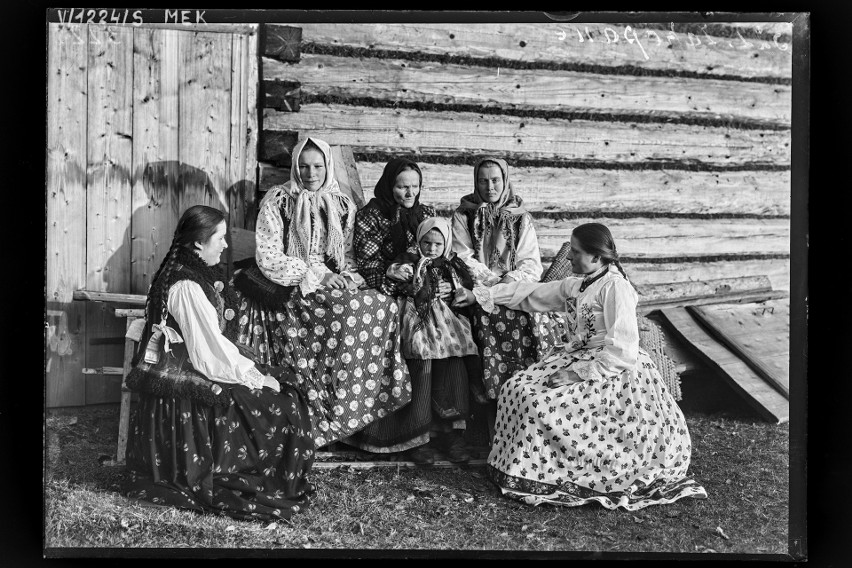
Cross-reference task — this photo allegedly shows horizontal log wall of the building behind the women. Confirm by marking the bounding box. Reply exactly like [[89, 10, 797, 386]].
[[259, 23, 792, 290]]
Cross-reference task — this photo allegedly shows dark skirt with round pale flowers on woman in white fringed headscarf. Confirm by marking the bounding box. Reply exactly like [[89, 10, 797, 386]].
[[236, 289, 411, 448]]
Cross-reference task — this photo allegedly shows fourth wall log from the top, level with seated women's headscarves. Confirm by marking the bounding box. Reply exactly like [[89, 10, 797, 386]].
[[350, 162, 791, 220]]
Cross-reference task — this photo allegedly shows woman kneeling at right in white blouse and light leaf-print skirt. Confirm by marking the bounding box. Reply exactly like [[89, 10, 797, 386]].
[[459, 223, 707, 511]]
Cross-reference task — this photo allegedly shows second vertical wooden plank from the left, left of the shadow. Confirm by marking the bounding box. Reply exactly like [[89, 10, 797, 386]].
[[85, 25, 133, 404]]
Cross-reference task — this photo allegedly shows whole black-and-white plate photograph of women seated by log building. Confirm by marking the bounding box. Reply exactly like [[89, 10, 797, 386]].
[[41, 8, 812, 562]]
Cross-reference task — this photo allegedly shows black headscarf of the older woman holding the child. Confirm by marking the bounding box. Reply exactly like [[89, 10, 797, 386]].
[[367, 158, 423, 258]]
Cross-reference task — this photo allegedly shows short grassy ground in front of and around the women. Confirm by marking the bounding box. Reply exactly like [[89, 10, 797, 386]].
[[44, 405, 789, 556]]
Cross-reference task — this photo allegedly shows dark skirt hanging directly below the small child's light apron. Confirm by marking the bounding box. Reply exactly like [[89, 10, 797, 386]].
[[344, 355, 481, 453]]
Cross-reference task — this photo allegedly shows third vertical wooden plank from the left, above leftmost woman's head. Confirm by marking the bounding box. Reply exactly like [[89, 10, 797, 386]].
[[130, 28, 185, 294]]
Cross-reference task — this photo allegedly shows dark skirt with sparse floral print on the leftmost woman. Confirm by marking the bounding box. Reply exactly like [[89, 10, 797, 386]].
[[127, 385, 314, 521]]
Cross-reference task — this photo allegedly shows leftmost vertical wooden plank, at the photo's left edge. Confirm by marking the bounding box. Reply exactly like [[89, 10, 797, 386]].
[[45, 24, 88, 407]]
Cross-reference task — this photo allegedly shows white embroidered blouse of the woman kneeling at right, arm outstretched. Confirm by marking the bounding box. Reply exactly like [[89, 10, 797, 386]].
[[476, 265, 639, 380]]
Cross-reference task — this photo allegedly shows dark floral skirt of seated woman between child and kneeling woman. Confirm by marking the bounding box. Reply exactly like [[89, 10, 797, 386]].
[[471, 304, 565, 400]]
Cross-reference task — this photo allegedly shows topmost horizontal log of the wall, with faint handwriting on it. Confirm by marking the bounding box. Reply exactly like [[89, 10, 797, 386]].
[[292, 22, 792, 79]]
